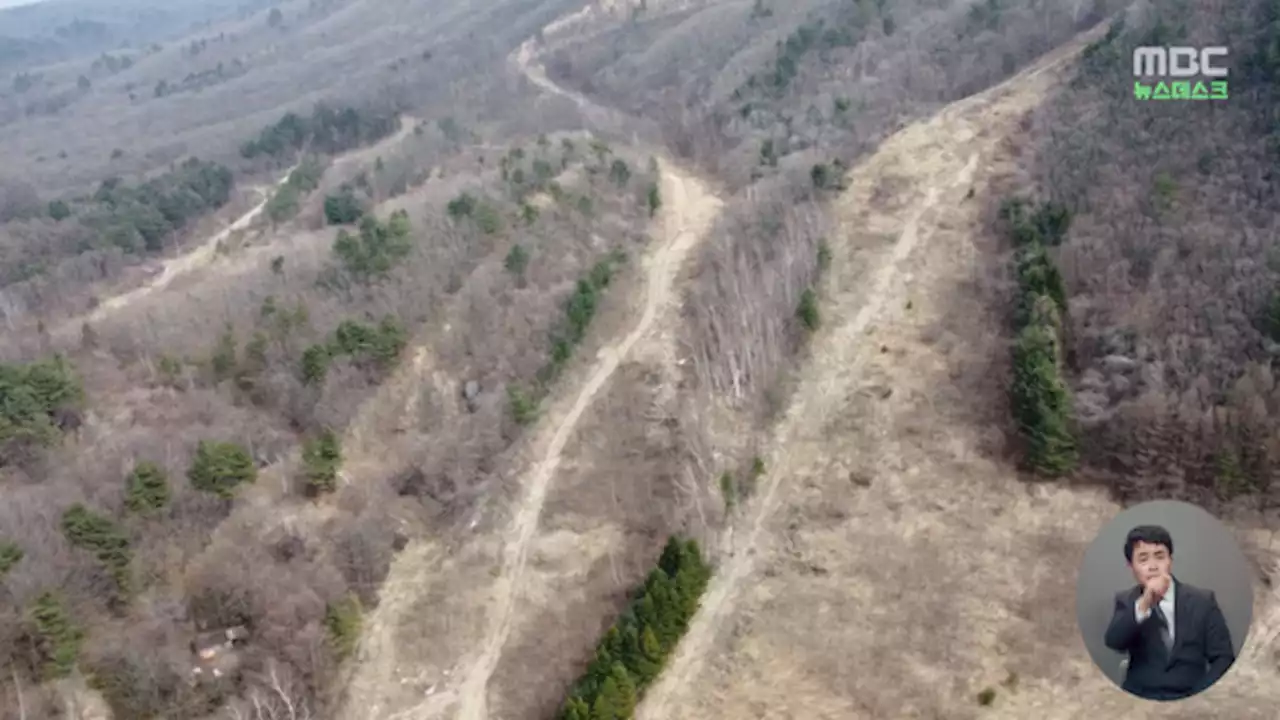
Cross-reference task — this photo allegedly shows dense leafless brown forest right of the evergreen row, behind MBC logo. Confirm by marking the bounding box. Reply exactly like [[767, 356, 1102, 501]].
[[1033, 1, 1280, 506]]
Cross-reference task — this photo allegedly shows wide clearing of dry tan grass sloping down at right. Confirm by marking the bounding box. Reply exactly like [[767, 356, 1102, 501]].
[[637, 28, 1276, 720]]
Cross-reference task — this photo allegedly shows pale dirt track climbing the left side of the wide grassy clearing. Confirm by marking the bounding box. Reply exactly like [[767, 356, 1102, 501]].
[[636, 25, 1126, 720]]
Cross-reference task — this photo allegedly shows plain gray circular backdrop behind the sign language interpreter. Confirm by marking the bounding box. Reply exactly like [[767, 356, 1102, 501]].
[[1075, 500, 1253, 685]]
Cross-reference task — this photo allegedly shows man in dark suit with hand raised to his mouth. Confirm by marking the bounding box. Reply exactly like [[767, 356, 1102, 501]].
[[1106, 525, 1235, 700]]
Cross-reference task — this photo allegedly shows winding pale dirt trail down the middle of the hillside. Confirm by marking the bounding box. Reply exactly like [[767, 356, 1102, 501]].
[[344, 18, 721, 720]]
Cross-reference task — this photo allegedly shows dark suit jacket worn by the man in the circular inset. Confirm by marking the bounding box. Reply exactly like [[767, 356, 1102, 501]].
[[1106, 578, 1235, 700]]
